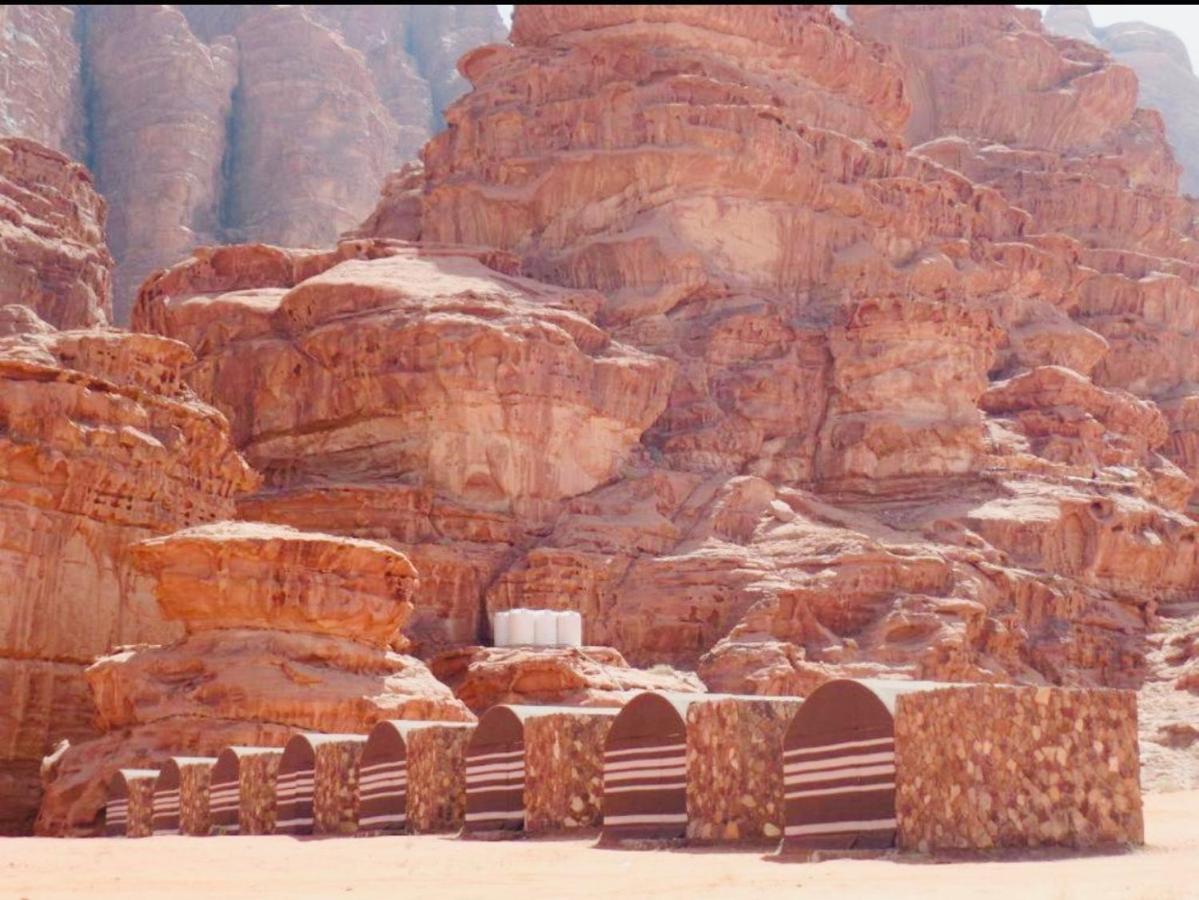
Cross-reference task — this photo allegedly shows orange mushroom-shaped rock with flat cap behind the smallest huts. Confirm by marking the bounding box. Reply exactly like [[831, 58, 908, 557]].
[[37, 523, 472, 834]]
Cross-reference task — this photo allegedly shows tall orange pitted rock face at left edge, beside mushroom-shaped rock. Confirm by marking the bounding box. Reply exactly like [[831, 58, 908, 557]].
[[0, 321, 257, 832]]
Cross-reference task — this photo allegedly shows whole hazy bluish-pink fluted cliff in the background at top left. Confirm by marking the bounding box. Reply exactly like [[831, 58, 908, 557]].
[[0, 5, 505, 324]]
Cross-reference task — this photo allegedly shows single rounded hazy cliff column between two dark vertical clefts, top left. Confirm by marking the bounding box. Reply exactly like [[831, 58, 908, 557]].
[[84, 5, 237, 322]]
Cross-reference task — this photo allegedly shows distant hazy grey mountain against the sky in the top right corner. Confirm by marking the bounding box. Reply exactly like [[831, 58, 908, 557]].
[[1044, 6, 1199, 195]]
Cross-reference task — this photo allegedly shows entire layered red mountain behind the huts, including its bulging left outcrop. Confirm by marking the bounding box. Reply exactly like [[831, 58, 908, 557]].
[[137, 6, 1199, 795]]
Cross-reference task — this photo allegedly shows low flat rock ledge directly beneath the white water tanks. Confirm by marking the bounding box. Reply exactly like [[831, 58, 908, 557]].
[[429, 647, 705, 713]]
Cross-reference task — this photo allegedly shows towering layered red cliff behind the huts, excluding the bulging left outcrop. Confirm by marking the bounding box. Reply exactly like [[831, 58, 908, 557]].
[[260, 6, 1199, 784]]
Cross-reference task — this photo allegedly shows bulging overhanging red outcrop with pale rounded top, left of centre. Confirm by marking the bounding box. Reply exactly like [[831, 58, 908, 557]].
[[134, 241, 671, 648]]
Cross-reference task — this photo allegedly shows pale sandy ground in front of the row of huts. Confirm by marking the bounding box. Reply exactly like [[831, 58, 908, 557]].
[[0, 791, 1199, 900]]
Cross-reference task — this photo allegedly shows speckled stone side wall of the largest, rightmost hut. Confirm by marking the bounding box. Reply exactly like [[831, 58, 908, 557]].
[[896, 684, 1145, 852]]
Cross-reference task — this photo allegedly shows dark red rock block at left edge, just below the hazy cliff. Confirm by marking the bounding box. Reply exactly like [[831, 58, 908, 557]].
[[0, 138, 113, 328]]
